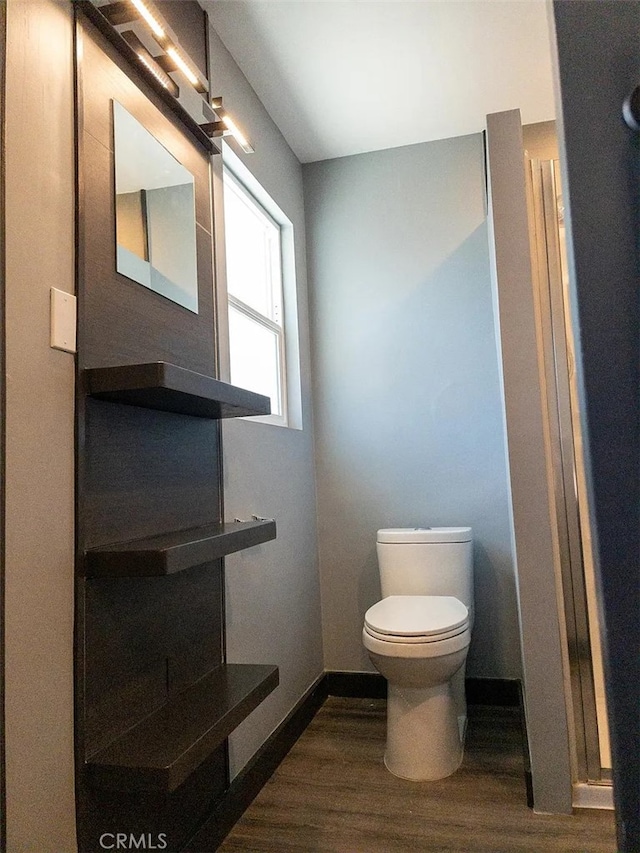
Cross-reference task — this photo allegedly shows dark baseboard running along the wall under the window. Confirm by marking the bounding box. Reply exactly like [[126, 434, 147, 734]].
[[182, 675, 327, 853]]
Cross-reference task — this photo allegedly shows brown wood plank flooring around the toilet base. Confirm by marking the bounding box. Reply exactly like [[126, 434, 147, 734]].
[[219, 697, 615, 853]]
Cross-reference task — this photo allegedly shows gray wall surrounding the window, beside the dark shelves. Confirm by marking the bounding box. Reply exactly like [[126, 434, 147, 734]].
[[210, 23, 323, 775]]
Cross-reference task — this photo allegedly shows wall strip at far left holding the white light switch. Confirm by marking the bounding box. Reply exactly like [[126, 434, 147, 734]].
[[4, 0, 76, 853]]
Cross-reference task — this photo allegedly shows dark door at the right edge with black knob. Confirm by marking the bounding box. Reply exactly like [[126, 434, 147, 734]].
[[553, 0, 640, 853]]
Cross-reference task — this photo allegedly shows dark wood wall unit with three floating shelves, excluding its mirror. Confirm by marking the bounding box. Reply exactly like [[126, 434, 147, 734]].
[[74, 16, 278, 853]]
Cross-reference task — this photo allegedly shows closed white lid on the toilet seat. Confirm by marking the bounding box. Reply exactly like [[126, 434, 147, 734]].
[[364, 595, 469, 637]]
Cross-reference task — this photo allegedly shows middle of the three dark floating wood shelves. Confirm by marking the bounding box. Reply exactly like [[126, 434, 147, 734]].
[[85, 519, 276, 578]]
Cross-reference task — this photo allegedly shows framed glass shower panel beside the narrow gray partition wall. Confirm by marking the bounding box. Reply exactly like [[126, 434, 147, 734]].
[[531, 160, 611, 782]]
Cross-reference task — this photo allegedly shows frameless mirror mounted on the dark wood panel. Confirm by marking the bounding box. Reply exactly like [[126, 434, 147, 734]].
[[113, 101, 198, 314]]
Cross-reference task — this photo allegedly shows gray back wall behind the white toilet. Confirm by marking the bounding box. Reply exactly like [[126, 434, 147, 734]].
[[303, 135, 520, 677]]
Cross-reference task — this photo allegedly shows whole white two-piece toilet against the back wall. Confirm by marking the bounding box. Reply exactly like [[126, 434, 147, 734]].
[[362, 527, 473, 780]]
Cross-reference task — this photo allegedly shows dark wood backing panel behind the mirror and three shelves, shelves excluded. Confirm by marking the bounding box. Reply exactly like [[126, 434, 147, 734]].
[[76, 16, 228, 853]]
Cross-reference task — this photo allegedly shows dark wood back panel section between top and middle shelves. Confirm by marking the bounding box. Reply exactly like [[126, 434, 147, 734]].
[[81, 398, 222, 553]]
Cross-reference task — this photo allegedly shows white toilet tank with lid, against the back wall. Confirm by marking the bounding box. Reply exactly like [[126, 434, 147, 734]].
[[376, 527, 473, 613]]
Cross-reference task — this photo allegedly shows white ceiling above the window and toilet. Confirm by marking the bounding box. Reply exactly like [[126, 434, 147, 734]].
[[201, 0, 554, 162]]
